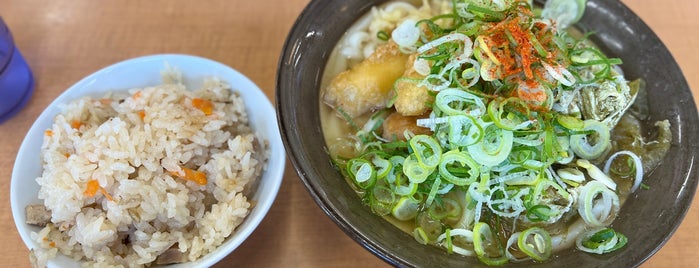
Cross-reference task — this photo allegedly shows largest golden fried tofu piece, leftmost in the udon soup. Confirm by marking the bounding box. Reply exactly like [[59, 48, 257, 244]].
[[323, 41, 408, 118]]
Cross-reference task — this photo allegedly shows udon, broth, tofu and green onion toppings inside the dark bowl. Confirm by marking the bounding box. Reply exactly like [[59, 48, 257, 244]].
[[321, 0, 671, 265]]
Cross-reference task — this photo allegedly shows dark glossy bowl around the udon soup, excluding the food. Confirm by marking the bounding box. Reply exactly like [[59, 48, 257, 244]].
[[276, 0, 699, 267]]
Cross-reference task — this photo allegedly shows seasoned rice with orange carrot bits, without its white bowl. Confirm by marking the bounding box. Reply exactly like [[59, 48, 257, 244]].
[[27, 70, 268, 267]]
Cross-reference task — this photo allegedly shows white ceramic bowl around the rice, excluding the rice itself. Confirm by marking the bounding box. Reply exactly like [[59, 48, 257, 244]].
[[10, 54, 286, 267]]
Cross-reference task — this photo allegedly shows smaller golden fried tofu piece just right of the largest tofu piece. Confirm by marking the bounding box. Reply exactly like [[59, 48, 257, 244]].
[[393, 54, 434, 116]]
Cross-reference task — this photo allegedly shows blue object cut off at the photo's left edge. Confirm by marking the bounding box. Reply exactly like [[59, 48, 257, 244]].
[[0, 17, 34, 124]]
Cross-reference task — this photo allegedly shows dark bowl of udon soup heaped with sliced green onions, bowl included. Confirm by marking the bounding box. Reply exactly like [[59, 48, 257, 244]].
[[276, 0, 699, 267]]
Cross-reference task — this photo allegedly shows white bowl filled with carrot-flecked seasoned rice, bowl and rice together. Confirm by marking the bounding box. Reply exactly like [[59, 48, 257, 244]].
[[10, 54, 286, 267]]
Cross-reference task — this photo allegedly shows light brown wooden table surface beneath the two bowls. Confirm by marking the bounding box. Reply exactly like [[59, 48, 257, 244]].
[[0, 0, 699, 267]]
